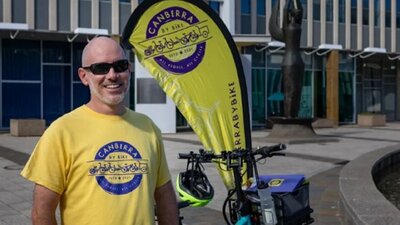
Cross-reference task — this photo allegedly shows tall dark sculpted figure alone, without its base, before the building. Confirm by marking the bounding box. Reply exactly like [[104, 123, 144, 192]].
[[269, 0, 304, 118]]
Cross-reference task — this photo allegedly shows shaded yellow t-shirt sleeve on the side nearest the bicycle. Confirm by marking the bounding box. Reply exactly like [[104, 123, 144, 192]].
[[156, 127, 171, 187]]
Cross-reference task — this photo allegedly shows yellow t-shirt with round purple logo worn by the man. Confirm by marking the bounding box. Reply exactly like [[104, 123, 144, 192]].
[[21, 106, 170, 225]]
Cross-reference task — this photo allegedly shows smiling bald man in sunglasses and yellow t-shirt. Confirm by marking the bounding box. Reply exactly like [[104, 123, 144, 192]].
[[21, 37, 178, 225]]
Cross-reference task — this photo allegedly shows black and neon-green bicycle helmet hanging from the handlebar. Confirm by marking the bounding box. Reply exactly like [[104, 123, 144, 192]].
[[176, 170, 214, 207]]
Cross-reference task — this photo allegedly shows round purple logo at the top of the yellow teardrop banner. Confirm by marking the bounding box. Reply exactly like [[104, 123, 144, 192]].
[[143, 7, 210, 74]]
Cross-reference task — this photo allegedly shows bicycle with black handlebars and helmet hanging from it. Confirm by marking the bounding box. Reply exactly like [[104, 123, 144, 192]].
[[176, 144, 314, 225]]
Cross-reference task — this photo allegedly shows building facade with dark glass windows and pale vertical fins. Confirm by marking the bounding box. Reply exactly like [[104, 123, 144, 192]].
[[0, 0, 400, 129]]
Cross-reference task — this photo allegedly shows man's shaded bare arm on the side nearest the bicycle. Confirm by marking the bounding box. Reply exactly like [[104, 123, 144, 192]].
[[154, 181, 179, 225]]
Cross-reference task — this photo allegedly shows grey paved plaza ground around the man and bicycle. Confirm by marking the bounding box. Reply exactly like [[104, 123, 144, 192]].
[[0, 123, 400, 225]]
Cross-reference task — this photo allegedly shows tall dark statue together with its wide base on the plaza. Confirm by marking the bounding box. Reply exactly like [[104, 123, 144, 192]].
[[267, 0, 337, 143]]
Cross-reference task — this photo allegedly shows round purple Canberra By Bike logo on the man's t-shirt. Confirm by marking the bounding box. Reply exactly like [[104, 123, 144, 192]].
[[89, 141, 148, 195]]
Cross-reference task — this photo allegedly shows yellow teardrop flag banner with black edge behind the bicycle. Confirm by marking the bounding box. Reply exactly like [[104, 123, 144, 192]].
[[121, 0, 251, 189]]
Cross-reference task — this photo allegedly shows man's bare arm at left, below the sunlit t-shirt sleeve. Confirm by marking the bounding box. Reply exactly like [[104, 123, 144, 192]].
[[32, 184, 60, 225]]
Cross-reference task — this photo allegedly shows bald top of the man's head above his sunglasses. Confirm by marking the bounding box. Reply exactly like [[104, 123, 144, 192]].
[[82, 37, 126, 66]]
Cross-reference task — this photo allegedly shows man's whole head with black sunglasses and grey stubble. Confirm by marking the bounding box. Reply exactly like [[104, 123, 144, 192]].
[[78, 37, 130, 112]]
